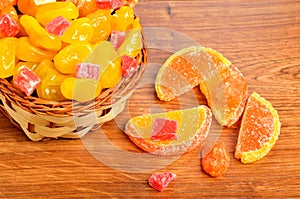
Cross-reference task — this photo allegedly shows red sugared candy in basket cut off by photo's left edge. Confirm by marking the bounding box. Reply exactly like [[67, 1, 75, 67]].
[[0, 14, 20, 38]]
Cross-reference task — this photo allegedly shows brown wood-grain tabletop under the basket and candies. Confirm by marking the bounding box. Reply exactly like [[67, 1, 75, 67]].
[[0, 0, 300, 198]]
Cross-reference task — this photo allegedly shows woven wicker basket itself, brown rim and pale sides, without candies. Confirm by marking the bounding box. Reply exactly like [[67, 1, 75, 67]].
[[0, 34, 147, 141]]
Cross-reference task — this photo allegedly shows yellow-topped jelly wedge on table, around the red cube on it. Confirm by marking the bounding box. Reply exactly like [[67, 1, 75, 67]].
[[125, 105, 212, 155]]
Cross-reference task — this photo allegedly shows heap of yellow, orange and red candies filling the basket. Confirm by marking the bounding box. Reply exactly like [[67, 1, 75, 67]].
[[0, 0, 143, 102]]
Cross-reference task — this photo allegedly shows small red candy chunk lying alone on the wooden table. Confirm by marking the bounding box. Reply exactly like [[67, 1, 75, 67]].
[[149, 172, 176, 191]]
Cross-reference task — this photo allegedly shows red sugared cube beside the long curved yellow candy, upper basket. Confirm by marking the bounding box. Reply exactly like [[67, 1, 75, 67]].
[[46, 16, 70, 36]]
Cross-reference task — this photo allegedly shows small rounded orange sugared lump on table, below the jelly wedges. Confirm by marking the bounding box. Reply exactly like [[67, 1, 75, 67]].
[[201, 140, 230, 177]]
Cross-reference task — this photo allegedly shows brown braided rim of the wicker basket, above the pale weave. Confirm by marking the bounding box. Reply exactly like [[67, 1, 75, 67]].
[[0, 29, 148, 117]]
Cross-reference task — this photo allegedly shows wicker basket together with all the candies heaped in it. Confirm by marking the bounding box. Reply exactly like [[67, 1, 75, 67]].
[[0, 0, 147, 141]]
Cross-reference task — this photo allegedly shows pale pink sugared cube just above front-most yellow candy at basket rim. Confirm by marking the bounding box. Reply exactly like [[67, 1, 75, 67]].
[[76, 63, 100, 80]]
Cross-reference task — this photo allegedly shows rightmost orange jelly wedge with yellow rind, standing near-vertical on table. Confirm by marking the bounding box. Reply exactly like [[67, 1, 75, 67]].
[[235, 93, 281, 163]]
